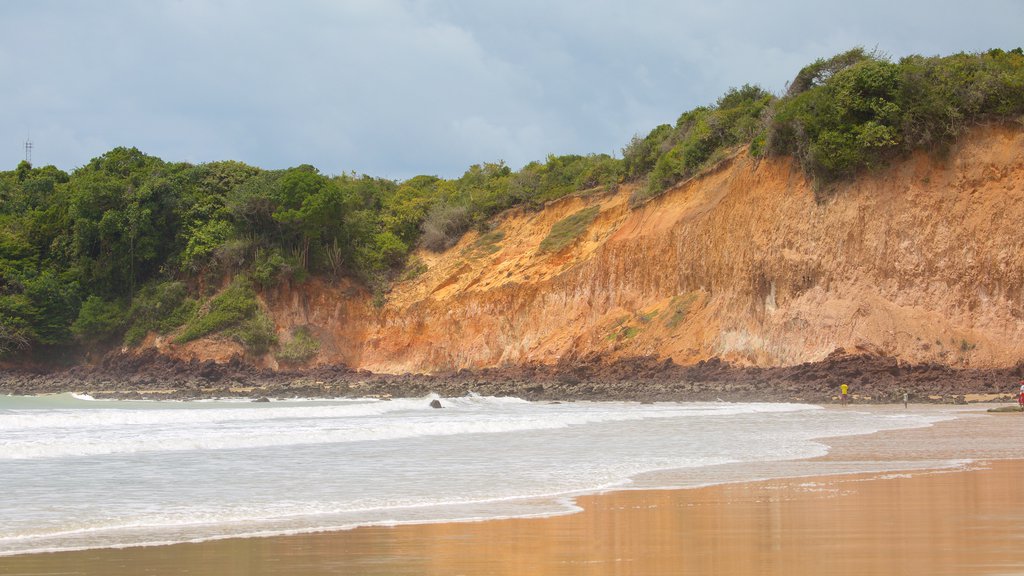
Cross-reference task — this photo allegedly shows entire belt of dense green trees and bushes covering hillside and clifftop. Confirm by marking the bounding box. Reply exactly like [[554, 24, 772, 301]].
[[0, 48, 1024, 362]]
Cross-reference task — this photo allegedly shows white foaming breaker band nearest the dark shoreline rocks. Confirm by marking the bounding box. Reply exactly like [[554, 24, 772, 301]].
[[0, 397, 817, 460]]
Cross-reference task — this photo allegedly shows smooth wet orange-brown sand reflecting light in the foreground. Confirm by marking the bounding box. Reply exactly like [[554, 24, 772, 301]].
[[0, 405, 1024, 576]]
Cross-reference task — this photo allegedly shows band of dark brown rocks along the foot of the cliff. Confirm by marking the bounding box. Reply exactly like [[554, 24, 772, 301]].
[[0, 349, 1024, 404]]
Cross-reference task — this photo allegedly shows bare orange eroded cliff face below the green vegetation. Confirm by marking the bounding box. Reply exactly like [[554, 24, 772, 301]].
[[155, 126, 1024, 372]]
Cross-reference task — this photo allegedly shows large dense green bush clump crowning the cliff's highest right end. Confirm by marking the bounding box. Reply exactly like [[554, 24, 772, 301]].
[[765, 49, 1024, 183]]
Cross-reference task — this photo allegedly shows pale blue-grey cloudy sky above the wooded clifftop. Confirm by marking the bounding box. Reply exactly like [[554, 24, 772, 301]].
[[0, 0, 1024, 180]]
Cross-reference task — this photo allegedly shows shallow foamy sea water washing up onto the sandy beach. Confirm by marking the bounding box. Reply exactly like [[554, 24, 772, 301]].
[[0, 395, 955, 556]]
